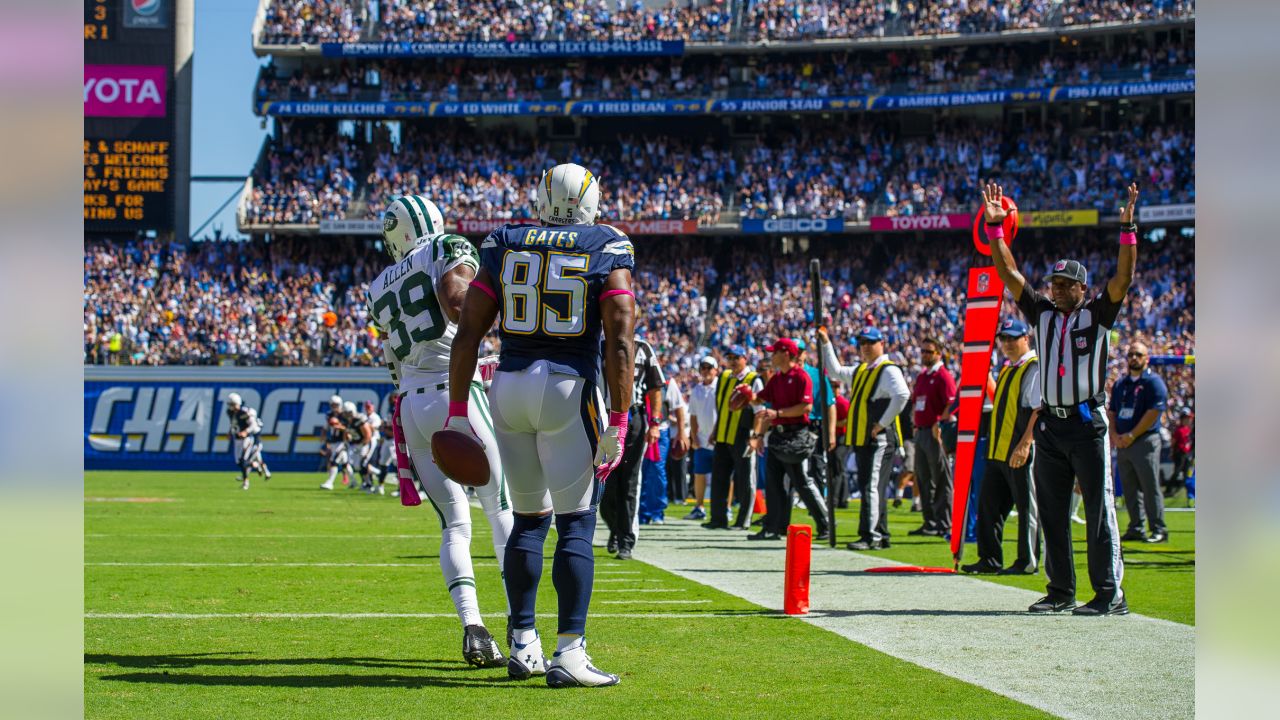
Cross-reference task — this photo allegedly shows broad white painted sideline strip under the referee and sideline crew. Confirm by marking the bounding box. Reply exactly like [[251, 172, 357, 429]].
[[624, 520, 1196, 720]]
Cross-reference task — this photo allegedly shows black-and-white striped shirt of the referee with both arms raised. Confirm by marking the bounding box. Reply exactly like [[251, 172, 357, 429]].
[[1018, 286, 1124, 407]]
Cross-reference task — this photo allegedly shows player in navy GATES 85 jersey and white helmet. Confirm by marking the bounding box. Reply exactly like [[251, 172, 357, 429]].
[[445, 164, 635, 688]]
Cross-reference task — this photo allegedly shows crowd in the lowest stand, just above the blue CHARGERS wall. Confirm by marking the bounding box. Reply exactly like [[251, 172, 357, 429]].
[[84, 232, 1196, 407]]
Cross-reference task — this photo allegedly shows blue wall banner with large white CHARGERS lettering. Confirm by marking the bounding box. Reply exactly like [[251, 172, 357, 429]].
[[84, 382, 392, 455]]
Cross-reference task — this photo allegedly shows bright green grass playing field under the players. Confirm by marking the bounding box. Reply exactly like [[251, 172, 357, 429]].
[[84, 473, 1194, 720]]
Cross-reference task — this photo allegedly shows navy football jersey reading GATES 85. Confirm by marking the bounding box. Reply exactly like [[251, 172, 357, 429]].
[[480, 224, 635, 383]]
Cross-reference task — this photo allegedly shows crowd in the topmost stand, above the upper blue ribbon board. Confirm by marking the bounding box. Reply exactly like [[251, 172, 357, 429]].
[[254, 0, 1196, 45]]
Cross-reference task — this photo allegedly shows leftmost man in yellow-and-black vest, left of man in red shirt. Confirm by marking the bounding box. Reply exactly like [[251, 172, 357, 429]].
[[703, 345, 764, 530]]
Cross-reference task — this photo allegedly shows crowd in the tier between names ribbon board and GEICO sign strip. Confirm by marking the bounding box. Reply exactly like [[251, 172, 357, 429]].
[[244, 117, 1196, 224]]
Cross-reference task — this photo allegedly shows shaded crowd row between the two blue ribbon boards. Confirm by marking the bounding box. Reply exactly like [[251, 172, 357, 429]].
[[257, 38, 1194, 102]]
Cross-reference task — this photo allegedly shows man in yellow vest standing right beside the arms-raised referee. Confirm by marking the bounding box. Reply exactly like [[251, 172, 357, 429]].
[[961, 318, 1041, 575]]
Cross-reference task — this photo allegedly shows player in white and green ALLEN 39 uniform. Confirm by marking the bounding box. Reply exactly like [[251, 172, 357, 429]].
[[369, 195, 512, 667]]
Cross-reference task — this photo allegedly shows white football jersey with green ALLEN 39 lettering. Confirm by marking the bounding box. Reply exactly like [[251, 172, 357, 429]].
[[369, 233, 480, 386]]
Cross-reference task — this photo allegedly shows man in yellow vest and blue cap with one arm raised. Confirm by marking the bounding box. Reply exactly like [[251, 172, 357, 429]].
[[818, 328, 911, 550]]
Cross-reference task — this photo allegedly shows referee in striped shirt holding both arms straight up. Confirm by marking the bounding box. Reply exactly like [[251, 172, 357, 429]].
[[982, 183, 1138, 616]]
